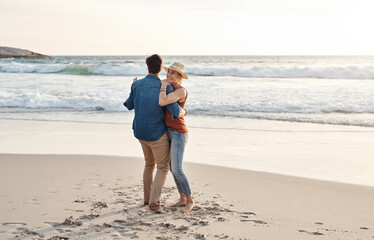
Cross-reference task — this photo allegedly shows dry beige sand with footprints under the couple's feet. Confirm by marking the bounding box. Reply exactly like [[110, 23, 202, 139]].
[[0, 154, 374, 239]]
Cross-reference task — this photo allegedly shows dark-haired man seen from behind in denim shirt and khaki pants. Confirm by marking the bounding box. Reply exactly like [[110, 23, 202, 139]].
[[123, 54, 185, 213]]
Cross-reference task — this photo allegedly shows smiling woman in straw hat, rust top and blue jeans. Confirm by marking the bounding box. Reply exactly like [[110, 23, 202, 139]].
[[159, 62, 194, 212]]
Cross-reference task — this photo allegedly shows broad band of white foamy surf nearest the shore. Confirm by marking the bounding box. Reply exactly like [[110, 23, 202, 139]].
[[0, 89, 374, 127]]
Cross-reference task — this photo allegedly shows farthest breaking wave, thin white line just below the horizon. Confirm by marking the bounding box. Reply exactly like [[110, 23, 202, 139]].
[[0, 62, 374, 79]]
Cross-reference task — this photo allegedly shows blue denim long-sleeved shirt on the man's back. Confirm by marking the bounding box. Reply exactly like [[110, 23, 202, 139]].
[[123, 74, 182, 141]]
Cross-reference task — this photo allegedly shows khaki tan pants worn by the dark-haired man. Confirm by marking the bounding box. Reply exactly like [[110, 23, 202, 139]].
[[139, 133, 170, 210]]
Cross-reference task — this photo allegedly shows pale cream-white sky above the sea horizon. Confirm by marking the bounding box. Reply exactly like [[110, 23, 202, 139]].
[[0, 0, 374, 55]]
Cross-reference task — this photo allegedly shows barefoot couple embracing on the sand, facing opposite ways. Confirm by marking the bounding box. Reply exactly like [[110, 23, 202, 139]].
[[123, 54, 194, 213]]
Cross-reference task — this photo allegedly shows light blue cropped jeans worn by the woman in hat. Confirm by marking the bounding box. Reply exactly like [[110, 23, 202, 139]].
[[168, 127, 191, 196]]
